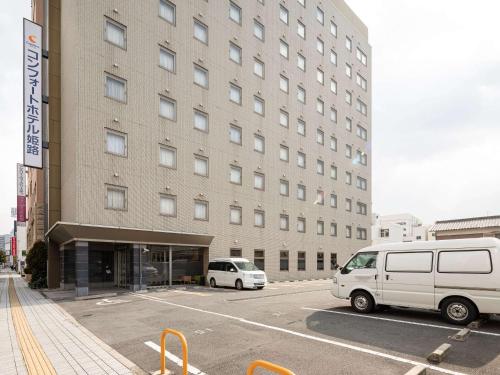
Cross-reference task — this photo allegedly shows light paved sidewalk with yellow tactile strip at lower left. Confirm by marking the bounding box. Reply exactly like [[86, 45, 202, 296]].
[[0, 272, 143, 375]]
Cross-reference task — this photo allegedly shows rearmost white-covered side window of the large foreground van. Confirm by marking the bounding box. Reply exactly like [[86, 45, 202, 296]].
[[438, 250, 493, 273]]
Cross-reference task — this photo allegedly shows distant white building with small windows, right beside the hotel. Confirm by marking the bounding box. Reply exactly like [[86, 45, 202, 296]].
[[372, 214, 432, 244]]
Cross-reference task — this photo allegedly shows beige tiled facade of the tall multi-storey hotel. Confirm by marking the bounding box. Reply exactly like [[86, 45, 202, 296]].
[[41, 0, 371, 280]]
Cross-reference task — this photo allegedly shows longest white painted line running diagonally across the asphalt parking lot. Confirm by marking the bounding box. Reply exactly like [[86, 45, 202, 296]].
[[131, 293, 465, 375]]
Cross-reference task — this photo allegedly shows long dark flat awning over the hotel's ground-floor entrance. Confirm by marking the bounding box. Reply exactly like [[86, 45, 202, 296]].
[[46, 221, 214, 247]]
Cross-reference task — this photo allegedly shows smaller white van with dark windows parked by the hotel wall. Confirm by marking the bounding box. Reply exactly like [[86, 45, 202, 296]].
[[207, 258, 267, 290]]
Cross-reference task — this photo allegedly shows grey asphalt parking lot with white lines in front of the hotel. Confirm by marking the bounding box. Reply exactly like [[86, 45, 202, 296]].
[[59, 280, 500, 375]]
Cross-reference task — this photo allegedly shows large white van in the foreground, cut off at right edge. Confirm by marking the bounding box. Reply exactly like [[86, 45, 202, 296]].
[[332, 238, 500, 325]]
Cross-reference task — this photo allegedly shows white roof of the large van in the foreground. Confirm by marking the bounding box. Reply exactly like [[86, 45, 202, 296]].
[[359, 237, 500, 251]]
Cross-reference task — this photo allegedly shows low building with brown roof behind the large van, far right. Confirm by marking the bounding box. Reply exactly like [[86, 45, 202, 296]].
[[429, 215, 500, 240]]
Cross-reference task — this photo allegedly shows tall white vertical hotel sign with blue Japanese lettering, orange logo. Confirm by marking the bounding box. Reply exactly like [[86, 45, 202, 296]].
[[23, 19, 43, 168]]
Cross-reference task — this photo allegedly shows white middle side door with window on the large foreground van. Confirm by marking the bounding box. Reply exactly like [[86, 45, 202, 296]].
[[382, 250, 434, 309]]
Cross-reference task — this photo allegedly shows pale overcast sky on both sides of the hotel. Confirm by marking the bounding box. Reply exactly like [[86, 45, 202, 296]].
[[0, 0, 500, 233]]
